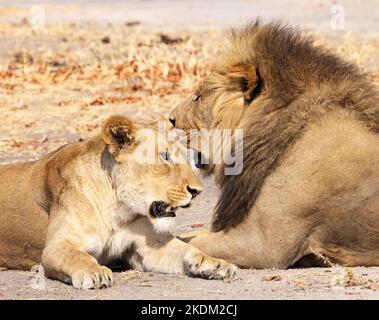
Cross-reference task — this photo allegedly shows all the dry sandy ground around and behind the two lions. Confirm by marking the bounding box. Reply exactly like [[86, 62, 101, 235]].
[[0, 0, 379, 299]]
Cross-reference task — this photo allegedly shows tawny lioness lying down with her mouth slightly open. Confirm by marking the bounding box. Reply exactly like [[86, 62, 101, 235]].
[[0, 116, 235, 289]]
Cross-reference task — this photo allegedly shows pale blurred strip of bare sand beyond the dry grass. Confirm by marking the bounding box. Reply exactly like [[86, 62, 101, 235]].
[[0, 0, 379, 33]]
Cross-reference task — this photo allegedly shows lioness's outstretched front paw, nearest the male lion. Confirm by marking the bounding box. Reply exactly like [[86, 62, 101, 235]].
[[184, 252, 237, 280]]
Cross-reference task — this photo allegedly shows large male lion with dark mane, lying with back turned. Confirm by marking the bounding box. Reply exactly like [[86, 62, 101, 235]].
[[170, 22, 379, 268]]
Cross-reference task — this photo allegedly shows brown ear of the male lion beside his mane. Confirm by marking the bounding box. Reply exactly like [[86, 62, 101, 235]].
[[229, 63, 259, 103]]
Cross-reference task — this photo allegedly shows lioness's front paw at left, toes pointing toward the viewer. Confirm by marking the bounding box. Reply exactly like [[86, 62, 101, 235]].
[[71, 266, 113, 290]]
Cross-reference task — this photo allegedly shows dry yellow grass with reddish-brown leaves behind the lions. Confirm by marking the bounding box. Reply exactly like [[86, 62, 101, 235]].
[[0, 20, 379, 163]]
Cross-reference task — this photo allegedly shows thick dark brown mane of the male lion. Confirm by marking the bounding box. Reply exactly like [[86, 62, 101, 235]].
[[212, 22, 379, 231]]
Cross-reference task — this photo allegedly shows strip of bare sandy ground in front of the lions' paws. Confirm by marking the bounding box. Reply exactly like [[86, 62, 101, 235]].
[[0, 268, 379, 300]]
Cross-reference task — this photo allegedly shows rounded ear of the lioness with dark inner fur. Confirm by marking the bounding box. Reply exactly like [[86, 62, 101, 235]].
[[102, 115, 136, 153]]
